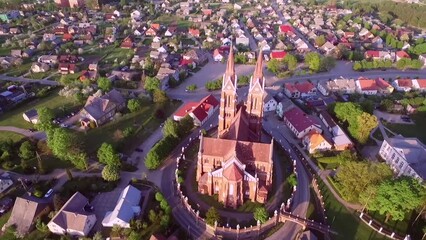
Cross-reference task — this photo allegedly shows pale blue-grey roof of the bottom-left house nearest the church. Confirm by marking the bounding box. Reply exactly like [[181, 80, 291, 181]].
[[102, 185, 141, 223]]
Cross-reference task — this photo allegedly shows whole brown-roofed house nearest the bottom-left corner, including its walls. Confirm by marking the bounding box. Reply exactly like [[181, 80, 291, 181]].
[[2, 197, 50, 236]]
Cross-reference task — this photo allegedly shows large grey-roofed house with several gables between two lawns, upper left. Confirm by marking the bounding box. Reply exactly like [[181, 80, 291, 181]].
[[80, 89, 126, 127]]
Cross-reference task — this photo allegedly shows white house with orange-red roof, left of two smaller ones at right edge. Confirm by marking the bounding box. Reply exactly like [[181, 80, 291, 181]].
[[355, 77, 394, 95]]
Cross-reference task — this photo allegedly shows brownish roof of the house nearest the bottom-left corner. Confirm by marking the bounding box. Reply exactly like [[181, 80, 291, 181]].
[[6, 197, 47, 234]]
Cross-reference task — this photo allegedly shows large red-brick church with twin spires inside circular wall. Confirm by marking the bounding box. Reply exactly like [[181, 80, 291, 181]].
[[196, 47, 273, 208]]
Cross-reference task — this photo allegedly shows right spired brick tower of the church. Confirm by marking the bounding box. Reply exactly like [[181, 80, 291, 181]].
[[246, 50, 265, 141]]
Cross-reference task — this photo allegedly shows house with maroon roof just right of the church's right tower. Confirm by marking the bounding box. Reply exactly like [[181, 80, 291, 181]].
[[284, 107, 322, 139]]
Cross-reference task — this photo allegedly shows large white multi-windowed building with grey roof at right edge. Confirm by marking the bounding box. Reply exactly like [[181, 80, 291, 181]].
[[379, 135, 426, 181]]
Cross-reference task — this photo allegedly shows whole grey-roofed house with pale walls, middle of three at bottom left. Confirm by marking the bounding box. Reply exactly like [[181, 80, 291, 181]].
[[47, 192, 96, 237]]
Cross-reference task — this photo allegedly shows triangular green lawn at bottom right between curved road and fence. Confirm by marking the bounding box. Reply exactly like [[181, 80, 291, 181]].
[[319, 178, 387, 240]]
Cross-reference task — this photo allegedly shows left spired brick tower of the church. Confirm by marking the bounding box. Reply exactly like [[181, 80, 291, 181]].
[[218, 45, 238, 137]]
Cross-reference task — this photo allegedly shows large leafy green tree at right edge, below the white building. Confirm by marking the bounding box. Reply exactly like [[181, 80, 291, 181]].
[[368, 177, 426, 222]]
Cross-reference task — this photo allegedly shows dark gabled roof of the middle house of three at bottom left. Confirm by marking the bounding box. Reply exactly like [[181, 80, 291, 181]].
[[50, 192, 94, 232]]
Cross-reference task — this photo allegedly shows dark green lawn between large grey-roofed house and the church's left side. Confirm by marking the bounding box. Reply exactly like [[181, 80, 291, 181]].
[[80, 102, 181, 153]]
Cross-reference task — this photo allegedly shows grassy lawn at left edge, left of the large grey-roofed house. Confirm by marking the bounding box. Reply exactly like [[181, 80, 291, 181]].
[[0, 91, 81, 128]]
